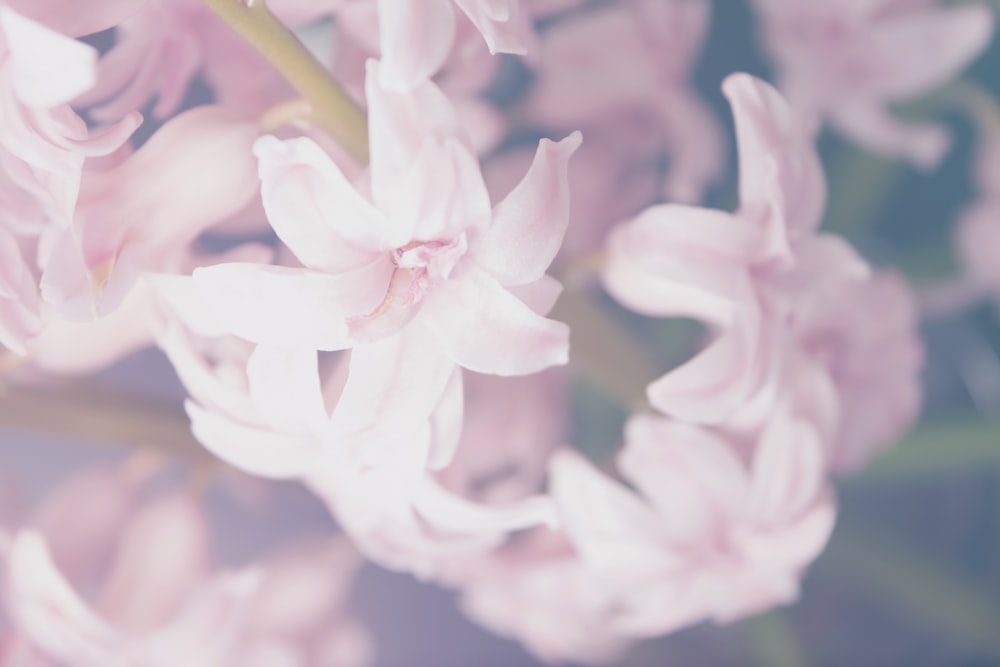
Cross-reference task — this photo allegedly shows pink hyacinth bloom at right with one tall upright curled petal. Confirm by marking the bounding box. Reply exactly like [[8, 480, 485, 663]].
[[603, 75, 922, 468]]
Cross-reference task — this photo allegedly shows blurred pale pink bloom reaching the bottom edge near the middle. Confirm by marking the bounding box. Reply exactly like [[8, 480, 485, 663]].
[[460, 530, 631, 665]]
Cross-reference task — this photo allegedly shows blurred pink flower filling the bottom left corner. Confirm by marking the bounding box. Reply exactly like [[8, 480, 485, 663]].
[[0, 466, 372, 667]]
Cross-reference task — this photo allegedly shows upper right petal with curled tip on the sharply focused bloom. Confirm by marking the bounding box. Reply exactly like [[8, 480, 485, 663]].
[[473, 132, 583, 285]]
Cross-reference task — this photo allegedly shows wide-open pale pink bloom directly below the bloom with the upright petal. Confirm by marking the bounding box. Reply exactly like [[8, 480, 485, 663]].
[[552, 408, 835, 637]]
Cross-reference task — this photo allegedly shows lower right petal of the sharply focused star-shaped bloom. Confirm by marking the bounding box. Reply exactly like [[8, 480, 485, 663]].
[[414, 267, 569, 375]]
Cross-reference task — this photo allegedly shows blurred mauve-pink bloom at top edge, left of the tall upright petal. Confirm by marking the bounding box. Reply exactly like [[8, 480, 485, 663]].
[[529, 0, 724, 202]]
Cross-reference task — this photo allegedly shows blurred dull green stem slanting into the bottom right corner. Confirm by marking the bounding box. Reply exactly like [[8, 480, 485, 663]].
[[820, 526, 1000, 659]]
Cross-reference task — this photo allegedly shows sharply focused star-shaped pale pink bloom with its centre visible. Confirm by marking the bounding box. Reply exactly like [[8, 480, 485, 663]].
[[194, 64, 580, 375]]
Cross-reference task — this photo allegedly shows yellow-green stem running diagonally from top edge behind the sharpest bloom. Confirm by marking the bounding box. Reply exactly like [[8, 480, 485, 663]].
[[204, 0, 368, 165]]
